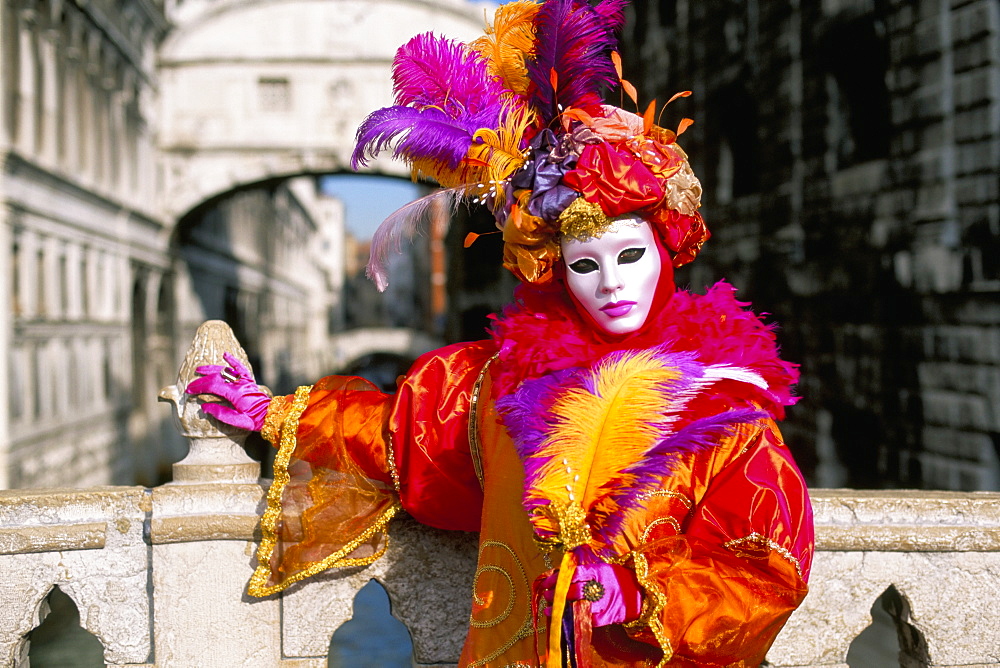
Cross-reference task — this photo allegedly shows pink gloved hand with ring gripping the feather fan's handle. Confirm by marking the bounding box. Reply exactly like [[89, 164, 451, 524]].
[[542, 561, 642, 627]]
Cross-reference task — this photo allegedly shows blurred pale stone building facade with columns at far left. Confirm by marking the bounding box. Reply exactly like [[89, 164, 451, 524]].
[[0, 0, 176, 487]]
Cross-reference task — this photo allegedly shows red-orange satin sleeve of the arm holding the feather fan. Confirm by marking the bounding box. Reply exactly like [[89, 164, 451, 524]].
[[631, 420, 813, 668]]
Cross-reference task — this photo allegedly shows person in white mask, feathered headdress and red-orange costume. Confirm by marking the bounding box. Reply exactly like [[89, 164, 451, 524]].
[[188, 0, 813, 668]]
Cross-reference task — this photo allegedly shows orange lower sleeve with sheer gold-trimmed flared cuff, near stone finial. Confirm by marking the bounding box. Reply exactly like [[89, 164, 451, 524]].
[[248, 376, 399, 596]]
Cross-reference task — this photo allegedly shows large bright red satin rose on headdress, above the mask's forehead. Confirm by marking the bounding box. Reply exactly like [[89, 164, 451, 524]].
[[563, 142, 663, 218]]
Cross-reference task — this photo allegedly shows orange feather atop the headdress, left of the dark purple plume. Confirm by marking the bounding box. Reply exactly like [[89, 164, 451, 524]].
[[469, 0, 540, 96]]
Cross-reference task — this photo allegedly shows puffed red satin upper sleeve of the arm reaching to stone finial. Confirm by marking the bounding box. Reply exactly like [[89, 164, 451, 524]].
[[389, 341, 496, 531]]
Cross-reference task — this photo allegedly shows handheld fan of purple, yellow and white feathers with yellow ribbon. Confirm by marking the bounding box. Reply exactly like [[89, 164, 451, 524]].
[[497, 349, 767, 666]]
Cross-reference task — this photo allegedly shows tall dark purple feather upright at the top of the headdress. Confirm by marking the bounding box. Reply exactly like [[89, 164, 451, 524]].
[[528, 0, 620, 124]]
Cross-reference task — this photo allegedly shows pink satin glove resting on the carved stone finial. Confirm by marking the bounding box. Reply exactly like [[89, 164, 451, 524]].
[[185, 353, 271, 431]]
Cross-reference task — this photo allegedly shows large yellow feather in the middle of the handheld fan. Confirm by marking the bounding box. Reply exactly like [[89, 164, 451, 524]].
[[536, 351, 678, 512]]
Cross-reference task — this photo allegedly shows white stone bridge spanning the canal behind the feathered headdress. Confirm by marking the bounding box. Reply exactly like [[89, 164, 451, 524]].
[[158, 0, 492, 221]]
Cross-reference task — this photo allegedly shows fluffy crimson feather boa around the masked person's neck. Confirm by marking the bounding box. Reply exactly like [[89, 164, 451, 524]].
[[491, 282, 799, 419]]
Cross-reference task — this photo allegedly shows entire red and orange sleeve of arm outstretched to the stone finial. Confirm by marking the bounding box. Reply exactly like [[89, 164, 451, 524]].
[[248, 342, 495, 596]]
